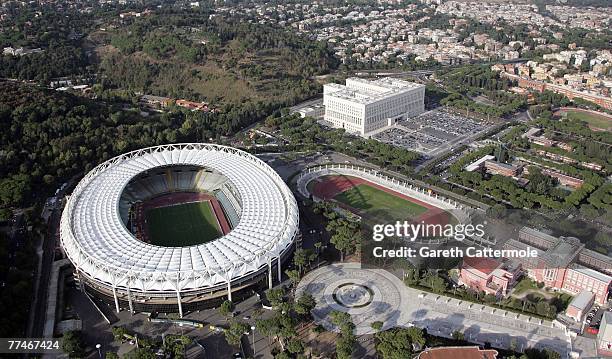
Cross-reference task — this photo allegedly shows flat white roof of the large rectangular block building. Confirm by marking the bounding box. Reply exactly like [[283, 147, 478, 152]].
[[325, 77, 425, 104]]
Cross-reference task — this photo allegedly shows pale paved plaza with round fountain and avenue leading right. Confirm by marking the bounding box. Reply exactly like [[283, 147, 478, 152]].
[[296, 263, 592, 357]]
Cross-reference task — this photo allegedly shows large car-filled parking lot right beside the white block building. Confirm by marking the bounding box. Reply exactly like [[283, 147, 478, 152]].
[[374, 109, 494, 155]]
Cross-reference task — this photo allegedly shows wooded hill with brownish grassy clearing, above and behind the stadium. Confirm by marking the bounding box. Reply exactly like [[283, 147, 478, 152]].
[[92, 13, 337, 104]]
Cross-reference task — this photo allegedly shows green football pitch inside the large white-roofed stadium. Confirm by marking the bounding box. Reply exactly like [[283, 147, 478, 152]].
[[146, 201, 222, 247]]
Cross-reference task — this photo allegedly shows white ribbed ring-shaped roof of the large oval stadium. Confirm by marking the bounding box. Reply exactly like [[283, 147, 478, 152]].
[[60, 144, 298, 292]]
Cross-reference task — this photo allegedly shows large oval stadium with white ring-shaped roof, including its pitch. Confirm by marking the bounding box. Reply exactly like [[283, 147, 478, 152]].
[[60, 143, 299, 316]]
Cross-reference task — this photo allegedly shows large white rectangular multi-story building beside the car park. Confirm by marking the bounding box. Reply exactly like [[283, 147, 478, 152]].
[[323, 78, 425, 137]]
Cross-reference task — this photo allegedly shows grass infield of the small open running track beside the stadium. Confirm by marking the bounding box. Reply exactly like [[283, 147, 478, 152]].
[[334, 184, 427, 221]]
